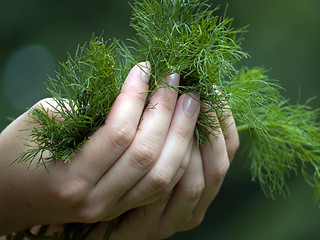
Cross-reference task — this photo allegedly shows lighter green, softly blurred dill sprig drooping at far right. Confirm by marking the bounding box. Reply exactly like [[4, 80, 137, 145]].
[[225, 68, 320, 202]]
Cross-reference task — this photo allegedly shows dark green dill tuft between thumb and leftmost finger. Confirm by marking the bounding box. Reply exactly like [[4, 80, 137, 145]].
[[17, 36, 121, 165]]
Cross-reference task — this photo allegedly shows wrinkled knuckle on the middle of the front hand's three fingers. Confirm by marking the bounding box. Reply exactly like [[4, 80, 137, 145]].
[[131, 143, 159, 169]]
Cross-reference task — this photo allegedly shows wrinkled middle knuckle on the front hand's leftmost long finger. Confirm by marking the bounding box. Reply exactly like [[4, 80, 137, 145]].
[[109, 125, 135, 148]]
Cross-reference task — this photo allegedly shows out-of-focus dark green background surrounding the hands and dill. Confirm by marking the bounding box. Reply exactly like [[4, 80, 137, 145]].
[[0, 0, 320, 240]]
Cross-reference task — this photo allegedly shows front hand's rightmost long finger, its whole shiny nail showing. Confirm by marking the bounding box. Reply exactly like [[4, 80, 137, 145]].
[[118, 95, 200, 210]]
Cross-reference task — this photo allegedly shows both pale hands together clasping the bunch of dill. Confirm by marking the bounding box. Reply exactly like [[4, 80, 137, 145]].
[[0, 63, 239, 240]]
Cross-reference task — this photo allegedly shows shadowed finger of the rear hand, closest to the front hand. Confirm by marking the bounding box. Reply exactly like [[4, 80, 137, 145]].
[[160, 143, 205, 235]]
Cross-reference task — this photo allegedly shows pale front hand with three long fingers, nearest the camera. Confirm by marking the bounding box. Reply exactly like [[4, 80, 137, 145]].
[[0, 61, 200, 235]]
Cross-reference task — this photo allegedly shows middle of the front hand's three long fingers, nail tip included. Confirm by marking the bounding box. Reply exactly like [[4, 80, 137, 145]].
[[96, 74, 180, 204]]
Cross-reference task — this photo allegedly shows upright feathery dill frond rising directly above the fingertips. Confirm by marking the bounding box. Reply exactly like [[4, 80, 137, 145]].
[[120, 0, 248, 144]]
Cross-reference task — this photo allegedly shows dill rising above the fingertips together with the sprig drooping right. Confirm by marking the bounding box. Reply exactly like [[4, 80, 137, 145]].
[[119, 0, 320, 204]]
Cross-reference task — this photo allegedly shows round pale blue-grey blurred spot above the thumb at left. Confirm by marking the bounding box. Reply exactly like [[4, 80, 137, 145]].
[[2, 45, 56, 111]]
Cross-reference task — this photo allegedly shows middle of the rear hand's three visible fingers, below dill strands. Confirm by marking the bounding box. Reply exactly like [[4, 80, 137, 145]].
[[193, 110, 230, 218]]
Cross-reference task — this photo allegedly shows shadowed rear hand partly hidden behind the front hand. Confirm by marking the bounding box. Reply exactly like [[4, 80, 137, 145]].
[[84, 102, 239, 240]]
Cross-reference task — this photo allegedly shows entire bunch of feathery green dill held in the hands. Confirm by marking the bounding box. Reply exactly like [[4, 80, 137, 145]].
[[10, 0, 320, 239]]
